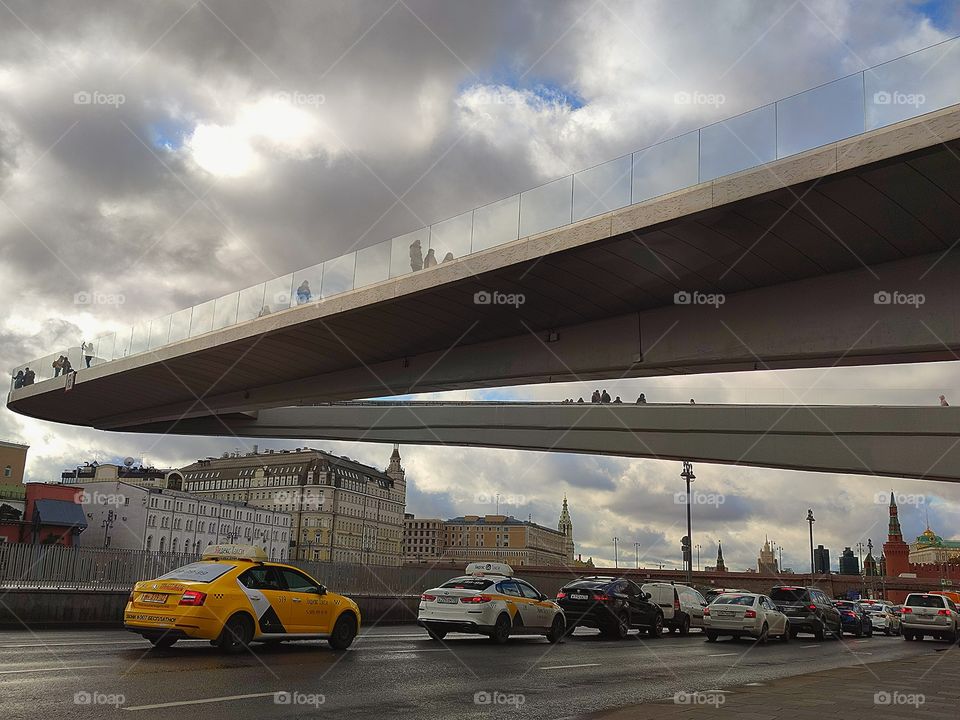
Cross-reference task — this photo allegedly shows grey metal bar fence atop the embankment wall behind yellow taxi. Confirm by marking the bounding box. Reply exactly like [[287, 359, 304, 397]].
[[0, 543, 462, 595]]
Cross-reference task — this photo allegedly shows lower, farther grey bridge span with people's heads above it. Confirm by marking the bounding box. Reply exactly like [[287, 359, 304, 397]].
[[128, 402, 960, 482]]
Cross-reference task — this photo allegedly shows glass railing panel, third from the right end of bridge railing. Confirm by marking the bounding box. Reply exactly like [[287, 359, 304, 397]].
[[700, 105, 777, 182]]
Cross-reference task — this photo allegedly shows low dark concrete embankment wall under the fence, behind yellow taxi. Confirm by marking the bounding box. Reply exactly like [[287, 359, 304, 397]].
[[0, 590, 420, 630]]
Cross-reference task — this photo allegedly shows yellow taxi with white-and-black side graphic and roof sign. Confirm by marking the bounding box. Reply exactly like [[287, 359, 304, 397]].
[[123, 545, 360, 652]]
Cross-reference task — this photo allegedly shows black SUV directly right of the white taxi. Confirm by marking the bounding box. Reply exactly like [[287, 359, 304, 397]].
[[557, 576, 663, 639]]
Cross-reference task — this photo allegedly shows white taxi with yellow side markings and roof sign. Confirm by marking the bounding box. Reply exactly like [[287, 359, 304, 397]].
[[417, 563, 567, 644]]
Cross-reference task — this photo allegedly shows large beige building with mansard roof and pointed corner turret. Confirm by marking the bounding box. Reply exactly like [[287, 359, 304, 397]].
[[181, 446, 407, 565]]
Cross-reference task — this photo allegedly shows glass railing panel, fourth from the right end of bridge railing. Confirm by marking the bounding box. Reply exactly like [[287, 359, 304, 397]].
[[632, 130, 700, 203]]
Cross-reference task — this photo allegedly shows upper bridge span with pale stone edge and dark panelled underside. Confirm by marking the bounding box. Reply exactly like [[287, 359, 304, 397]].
[[8, 102, 960, 428]]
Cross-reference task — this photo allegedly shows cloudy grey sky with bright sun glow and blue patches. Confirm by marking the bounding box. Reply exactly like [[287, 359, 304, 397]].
[[0, 0, 960, 568]]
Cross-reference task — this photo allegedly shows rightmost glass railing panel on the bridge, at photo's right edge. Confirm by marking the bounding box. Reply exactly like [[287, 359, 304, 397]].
[[864, 38, 960, 130]]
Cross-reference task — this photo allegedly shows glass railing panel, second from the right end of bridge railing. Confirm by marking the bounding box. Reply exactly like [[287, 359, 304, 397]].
[[777, 74, 863, 157]]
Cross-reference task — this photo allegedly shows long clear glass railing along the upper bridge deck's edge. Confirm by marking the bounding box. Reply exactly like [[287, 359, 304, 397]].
[[13, 38, 960, 388]]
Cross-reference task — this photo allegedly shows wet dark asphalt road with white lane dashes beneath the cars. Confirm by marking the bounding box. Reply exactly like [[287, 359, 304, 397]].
[[0, 626, 946, 720]]
